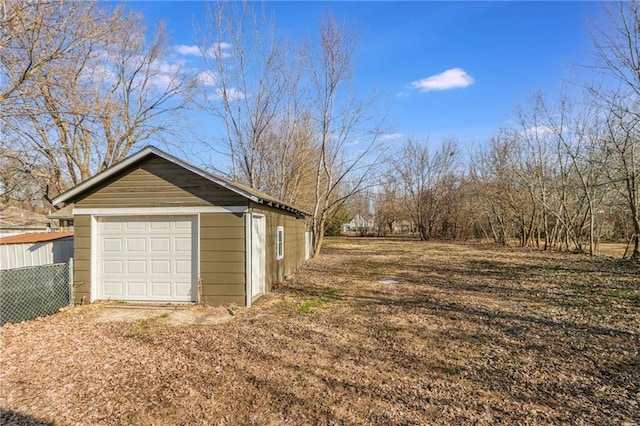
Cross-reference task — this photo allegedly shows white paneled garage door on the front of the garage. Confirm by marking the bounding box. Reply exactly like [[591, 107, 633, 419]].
[[98, 216, 197, 302]]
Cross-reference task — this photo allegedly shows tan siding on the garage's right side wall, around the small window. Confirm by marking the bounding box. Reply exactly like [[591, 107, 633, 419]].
[[250, 203, 305, 291]]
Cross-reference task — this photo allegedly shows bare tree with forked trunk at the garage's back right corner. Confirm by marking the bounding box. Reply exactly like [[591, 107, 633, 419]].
[[304, 15, 384, 257]]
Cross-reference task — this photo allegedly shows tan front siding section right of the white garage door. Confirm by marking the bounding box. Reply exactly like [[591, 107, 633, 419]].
[[200, 213, 246, 305]]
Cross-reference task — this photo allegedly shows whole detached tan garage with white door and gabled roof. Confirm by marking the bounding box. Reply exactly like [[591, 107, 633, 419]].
[[53, 146, 308, 306]]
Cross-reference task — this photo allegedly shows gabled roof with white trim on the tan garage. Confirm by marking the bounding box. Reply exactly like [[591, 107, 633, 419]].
[[52, 145, 308, 216]]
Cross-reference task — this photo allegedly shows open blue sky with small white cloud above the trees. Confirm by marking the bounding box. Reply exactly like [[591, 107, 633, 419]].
[[129, 1, 603, 164]]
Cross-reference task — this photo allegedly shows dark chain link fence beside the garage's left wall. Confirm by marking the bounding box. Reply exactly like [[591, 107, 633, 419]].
[[0, 263, 72, 326]]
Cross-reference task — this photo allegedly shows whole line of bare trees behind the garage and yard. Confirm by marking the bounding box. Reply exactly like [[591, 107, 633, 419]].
[[0, 0, 640, 259]]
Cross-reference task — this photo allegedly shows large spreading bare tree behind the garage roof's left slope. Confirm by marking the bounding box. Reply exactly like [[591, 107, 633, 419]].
[[4, 2, 193, 200]]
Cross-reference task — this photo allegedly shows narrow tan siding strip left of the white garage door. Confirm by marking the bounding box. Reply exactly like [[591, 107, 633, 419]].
[[73, 216, 91, 303]]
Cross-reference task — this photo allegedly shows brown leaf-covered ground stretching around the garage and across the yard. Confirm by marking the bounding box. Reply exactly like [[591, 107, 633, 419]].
[[0, 238, 640, 425]]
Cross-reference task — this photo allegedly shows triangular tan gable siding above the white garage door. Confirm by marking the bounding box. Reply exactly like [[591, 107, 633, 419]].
[[76, 157, 247, 208]]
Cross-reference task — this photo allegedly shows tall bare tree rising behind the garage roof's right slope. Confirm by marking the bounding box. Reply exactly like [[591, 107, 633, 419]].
[[198, 2, 308, 188]]
